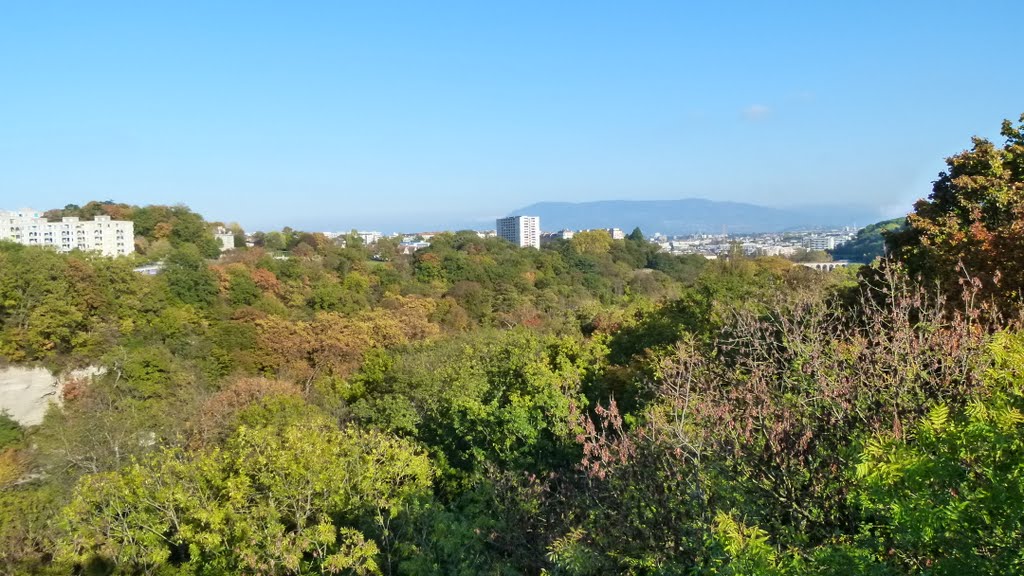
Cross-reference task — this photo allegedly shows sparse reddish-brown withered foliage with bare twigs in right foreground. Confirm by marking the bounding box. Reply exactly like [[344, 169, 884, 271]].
[[577, 273, 1011, 528]]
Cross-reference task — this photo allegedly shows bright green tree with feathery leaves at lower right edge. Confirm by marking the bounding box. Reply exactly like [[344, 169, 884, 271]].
[[857, 333, 1024, 575]]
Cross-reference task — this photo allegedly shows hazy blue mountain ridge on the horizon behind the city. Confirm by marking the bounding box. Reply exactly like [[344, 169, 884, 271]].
[[512, 198, 879, 235]]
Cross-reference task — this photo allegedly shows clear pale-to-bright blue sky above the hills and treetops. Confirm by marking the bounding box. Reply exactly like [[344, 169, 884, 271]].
[[0, 0, 1024, 230]]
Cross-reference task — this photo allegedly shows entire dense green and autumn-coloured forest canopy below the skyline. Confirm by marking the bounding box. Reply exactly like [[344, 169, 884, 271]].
[[0, 118, 1024, 575]]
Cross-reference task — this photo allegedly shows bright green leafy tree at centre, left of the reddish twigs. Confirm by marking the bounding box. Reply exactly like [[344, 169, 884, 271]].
[[353, 330, 597, 484]]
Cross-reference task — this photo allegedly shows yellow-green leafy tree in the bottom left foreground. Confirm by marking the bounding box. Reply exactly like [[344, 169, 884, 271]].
[[57, 419, 430, 575]]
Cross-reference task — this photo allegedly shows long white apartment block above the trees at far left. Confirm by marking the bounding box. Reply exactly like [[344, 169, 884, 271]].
[[0, 210, 135, 256]]
